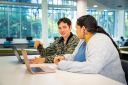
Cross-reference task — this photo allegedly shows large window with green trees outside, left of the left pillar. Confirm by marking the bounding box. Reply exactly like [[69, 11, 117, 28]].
[[0, 0, 42, 38]]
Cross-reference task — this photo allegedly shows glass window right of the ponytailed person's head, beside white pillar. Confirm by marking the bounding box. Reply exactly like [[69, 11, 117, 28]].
[[87, 9, 115, 37]]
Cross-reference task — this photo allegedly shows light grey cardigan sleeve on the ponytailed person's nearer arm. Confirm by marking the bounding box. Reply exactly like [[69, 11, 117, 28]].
[[58, 36, 113, 74]]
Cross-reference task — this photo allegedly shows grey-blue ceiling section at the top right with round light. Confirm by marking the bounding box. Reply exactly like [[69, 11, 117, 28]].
[[87, 0, 128, 10]]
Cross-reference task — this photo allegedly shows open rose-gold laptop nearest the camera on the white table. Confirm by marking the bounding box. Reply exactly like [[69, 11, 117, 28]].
[[21, 49, 55, 74]]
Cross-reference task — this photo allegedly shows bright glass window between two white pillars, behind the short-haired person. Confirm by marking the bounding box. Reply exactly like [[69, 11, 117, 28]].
[[48, 0, 76, 38]]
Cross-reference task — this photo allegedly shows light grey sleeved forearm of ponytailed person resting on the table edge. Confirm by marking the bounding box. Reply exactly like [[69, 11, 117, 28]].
[[58, 60, 101, 74]]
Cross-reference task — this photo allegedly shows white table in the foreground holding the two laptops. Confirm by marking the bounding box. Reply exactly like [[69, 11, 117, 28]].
[[0, 56, 123, 85]]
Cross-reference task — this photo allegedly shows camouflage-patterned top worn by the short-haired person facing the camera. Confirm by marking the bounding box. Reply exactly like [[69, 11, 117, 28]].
[[37, 33, 79, 63]]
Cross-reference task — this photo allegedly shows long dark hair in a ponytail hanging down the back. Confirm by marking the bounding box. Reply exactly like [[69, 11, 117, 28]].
[[77, 15, 121, 56]]
